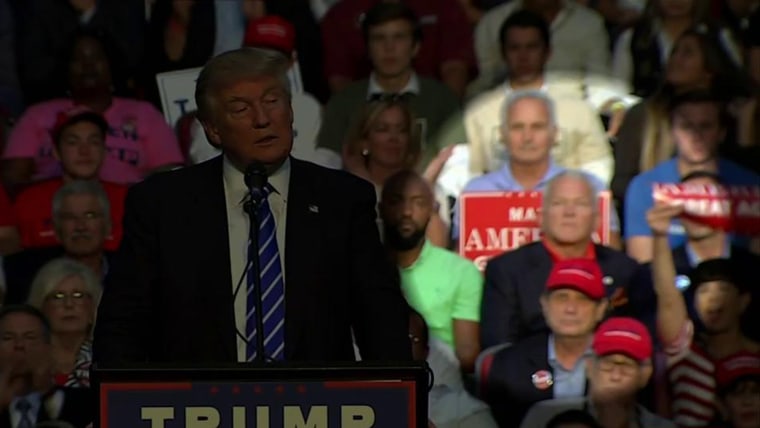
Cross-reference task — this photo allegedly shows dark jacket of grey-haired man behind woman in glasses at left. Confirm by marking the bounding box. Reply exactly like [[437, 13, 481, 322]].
[[3, 247, 111, 304]]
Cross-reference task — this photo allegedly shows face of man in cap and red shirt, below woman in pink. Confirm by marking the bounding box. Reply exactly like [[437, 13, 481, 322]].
[[56, 122, 106, 180]]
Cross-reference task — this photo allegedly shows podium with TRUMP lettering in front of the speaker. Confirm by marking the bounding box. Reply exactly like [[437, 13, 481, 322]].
[[91, 362, 430, 428]]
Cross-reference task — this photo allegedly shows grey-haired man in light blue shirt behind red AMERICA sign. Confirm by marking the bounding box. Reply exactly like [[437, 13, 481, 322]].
[[452, 90, 620, 248]]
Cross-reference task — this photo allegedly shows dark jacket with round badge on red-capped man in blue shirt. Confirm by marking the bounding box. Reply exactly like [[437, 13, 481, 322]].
[[485, 333, 554, 428]]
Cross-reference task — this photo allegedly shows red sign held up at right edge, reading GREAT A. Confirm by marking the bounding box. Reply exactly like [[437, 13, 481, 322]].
[[652, 183, 760, 235]]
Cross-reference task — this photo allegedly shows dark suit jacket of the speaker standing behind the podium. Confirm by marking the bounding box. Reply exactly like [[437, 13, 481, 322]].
[[93, 156, 411, 364]]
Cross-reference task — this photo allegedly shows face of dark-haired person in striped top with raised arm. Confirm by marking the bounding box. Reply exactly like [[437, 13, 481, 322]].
[[694, 281, 749, 334]]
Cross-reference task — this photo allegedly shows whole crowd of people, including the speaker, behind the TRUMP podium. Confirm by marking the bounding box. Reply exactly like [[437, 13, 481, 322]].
[[0, 0, 760, 428]]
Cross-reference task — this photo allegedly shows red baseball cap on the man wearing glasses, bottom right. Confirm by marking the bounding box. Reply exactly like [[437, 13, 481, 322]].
[[591, 317, 653, 362]]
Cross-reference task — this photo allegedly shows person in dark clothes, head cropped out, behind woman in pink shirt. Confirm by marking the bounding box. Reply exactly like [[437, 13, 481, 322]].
[[18, 0, 145, 104]]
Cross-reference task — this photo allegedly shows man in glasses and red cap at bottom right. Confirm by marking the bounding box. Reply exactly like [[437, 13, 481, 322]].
[[521, 317, 676, 428]]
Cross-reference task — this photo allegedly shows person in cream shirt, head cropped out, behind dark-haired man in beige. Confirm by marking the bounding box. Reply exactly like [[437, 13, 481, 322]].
[[472, 0, 612, 109]]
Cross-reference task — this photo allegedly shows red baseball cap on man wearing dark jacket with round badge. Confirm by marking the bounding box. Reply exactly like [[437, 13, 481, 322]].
[[546, 259, 607, 300]]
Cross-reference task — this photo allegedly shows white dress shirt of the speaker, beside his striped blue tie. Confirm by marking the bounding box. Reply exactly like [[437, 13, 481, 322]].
[[223, 156, 290, 362]]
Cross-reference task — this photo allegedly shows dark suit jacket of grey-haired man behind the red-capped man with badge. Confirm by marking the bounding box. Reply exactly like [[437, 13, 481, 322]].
[[480, 242, 651, 349]]
